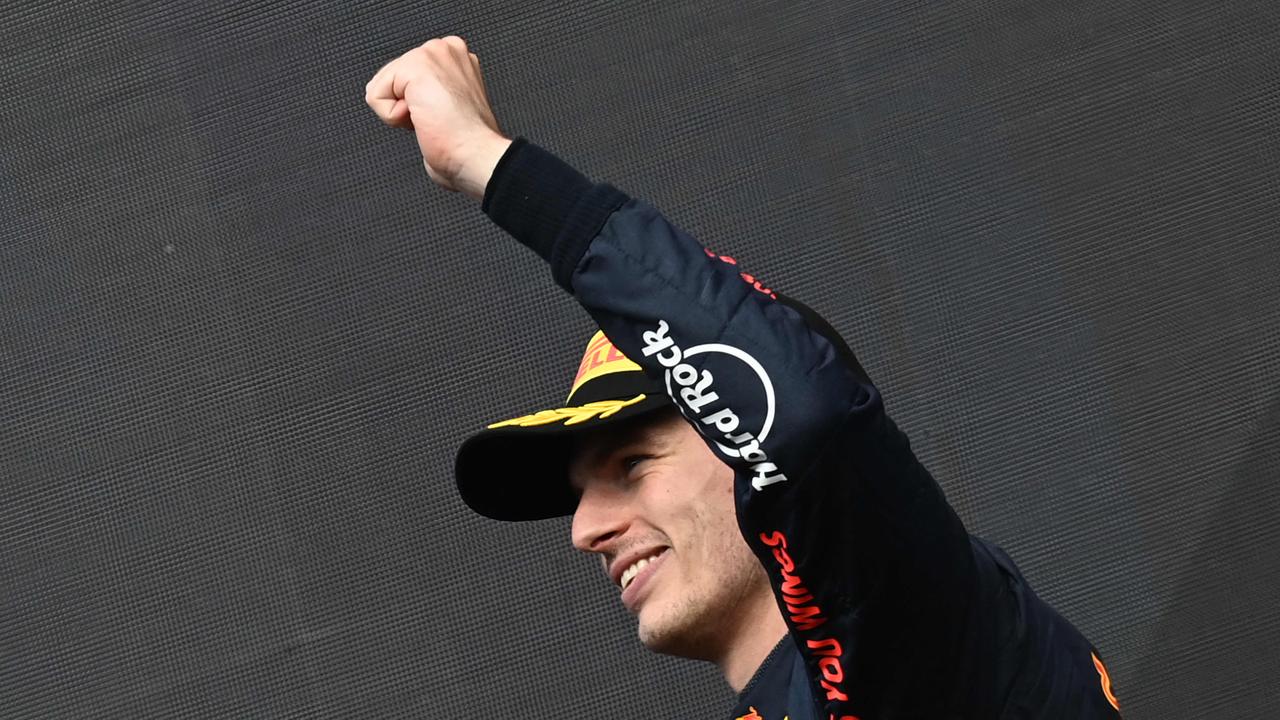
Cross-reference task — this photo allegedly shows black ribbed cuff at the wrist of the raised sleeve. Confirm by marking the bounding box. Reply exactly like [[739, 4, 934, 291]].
[[480, 137, 628, 292]]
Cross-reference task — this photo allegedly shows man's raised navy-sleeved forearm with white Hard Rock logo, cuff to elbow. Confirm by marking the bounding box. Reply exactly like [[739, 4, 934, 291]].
[[484, 138, 873, 491]]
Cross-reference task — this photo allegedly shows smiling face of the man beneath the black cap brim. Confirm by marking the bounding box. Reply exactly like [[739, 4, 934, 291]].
[[570, 411, 777, 661]]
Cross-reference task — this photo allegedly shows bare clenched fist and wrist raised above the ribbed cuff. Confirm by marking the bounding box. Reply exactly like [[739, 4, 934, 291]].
[[365, 36, 511, 200]]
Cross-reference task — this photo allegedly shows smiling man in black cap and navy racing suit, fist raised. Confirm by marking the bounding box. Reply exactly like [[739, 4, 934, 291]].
[[366, 37, 1119, 720]]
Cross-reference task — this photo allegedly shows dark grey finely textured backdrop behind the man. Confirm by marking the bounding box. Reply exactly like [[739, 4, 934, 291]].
[[0, 0, 1280, 720]]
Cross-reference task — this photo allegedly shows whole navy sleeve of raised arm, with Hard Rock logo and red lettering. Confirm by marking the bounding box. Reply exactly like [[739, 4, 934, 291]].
[[484, 138, 978, 719]]
